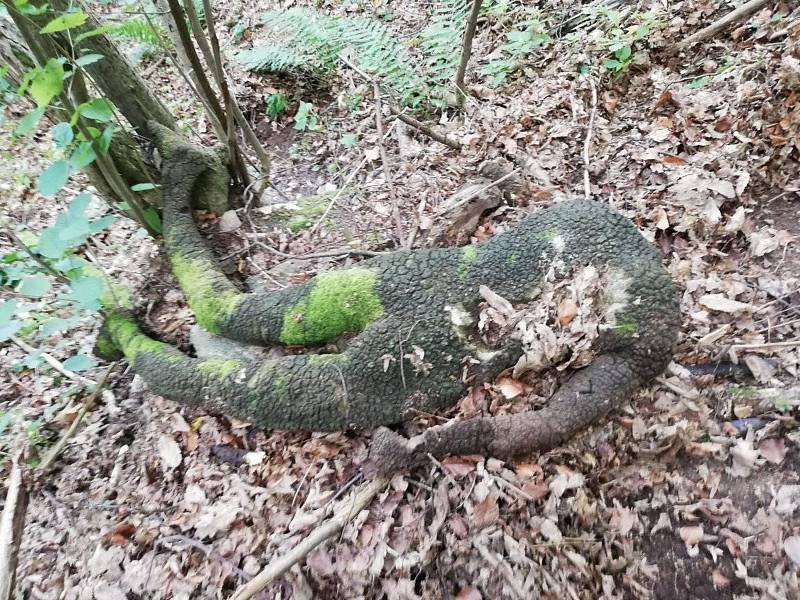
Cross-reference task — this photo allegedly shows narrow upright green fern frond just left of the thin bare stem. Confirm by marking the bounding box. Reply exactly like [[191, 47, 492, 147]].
[[420, 0, 472, 85]]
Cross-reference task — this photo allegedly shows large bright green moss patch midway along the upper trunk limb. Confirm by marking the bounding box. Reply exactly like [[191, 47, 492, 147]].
[[280, 268, 383, 346]]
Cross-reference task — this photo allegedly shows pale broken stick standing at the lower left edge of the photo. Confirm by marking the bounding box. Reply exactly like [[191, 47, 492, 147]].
[[0, 454, 28, 600]]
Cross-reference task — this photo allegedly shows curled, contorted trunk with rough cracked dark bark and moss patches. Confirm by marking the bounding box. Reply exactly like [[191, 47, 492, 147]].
[[97, 135, 679, 469]]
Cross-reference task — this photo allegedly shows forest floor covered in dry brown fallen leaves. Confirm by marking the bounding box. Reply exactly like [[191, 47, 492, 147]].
[[0, 0, 800, 600]]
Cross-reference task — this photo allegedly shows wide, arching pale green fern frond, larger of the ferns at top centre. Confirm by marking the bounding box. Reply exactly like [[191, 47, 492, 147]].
[[236, 8, 430, 104]]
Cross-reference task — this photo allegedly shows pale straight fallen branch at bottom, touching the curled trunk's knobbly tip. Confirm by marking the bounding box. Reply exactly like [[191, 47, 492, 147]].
[[231, 478, 389, 600]]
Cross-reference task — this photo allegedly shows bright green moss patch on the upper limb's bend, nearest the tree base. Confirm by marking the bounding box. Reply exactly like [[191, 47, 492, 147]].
[[170, 253, 242, 334]]
